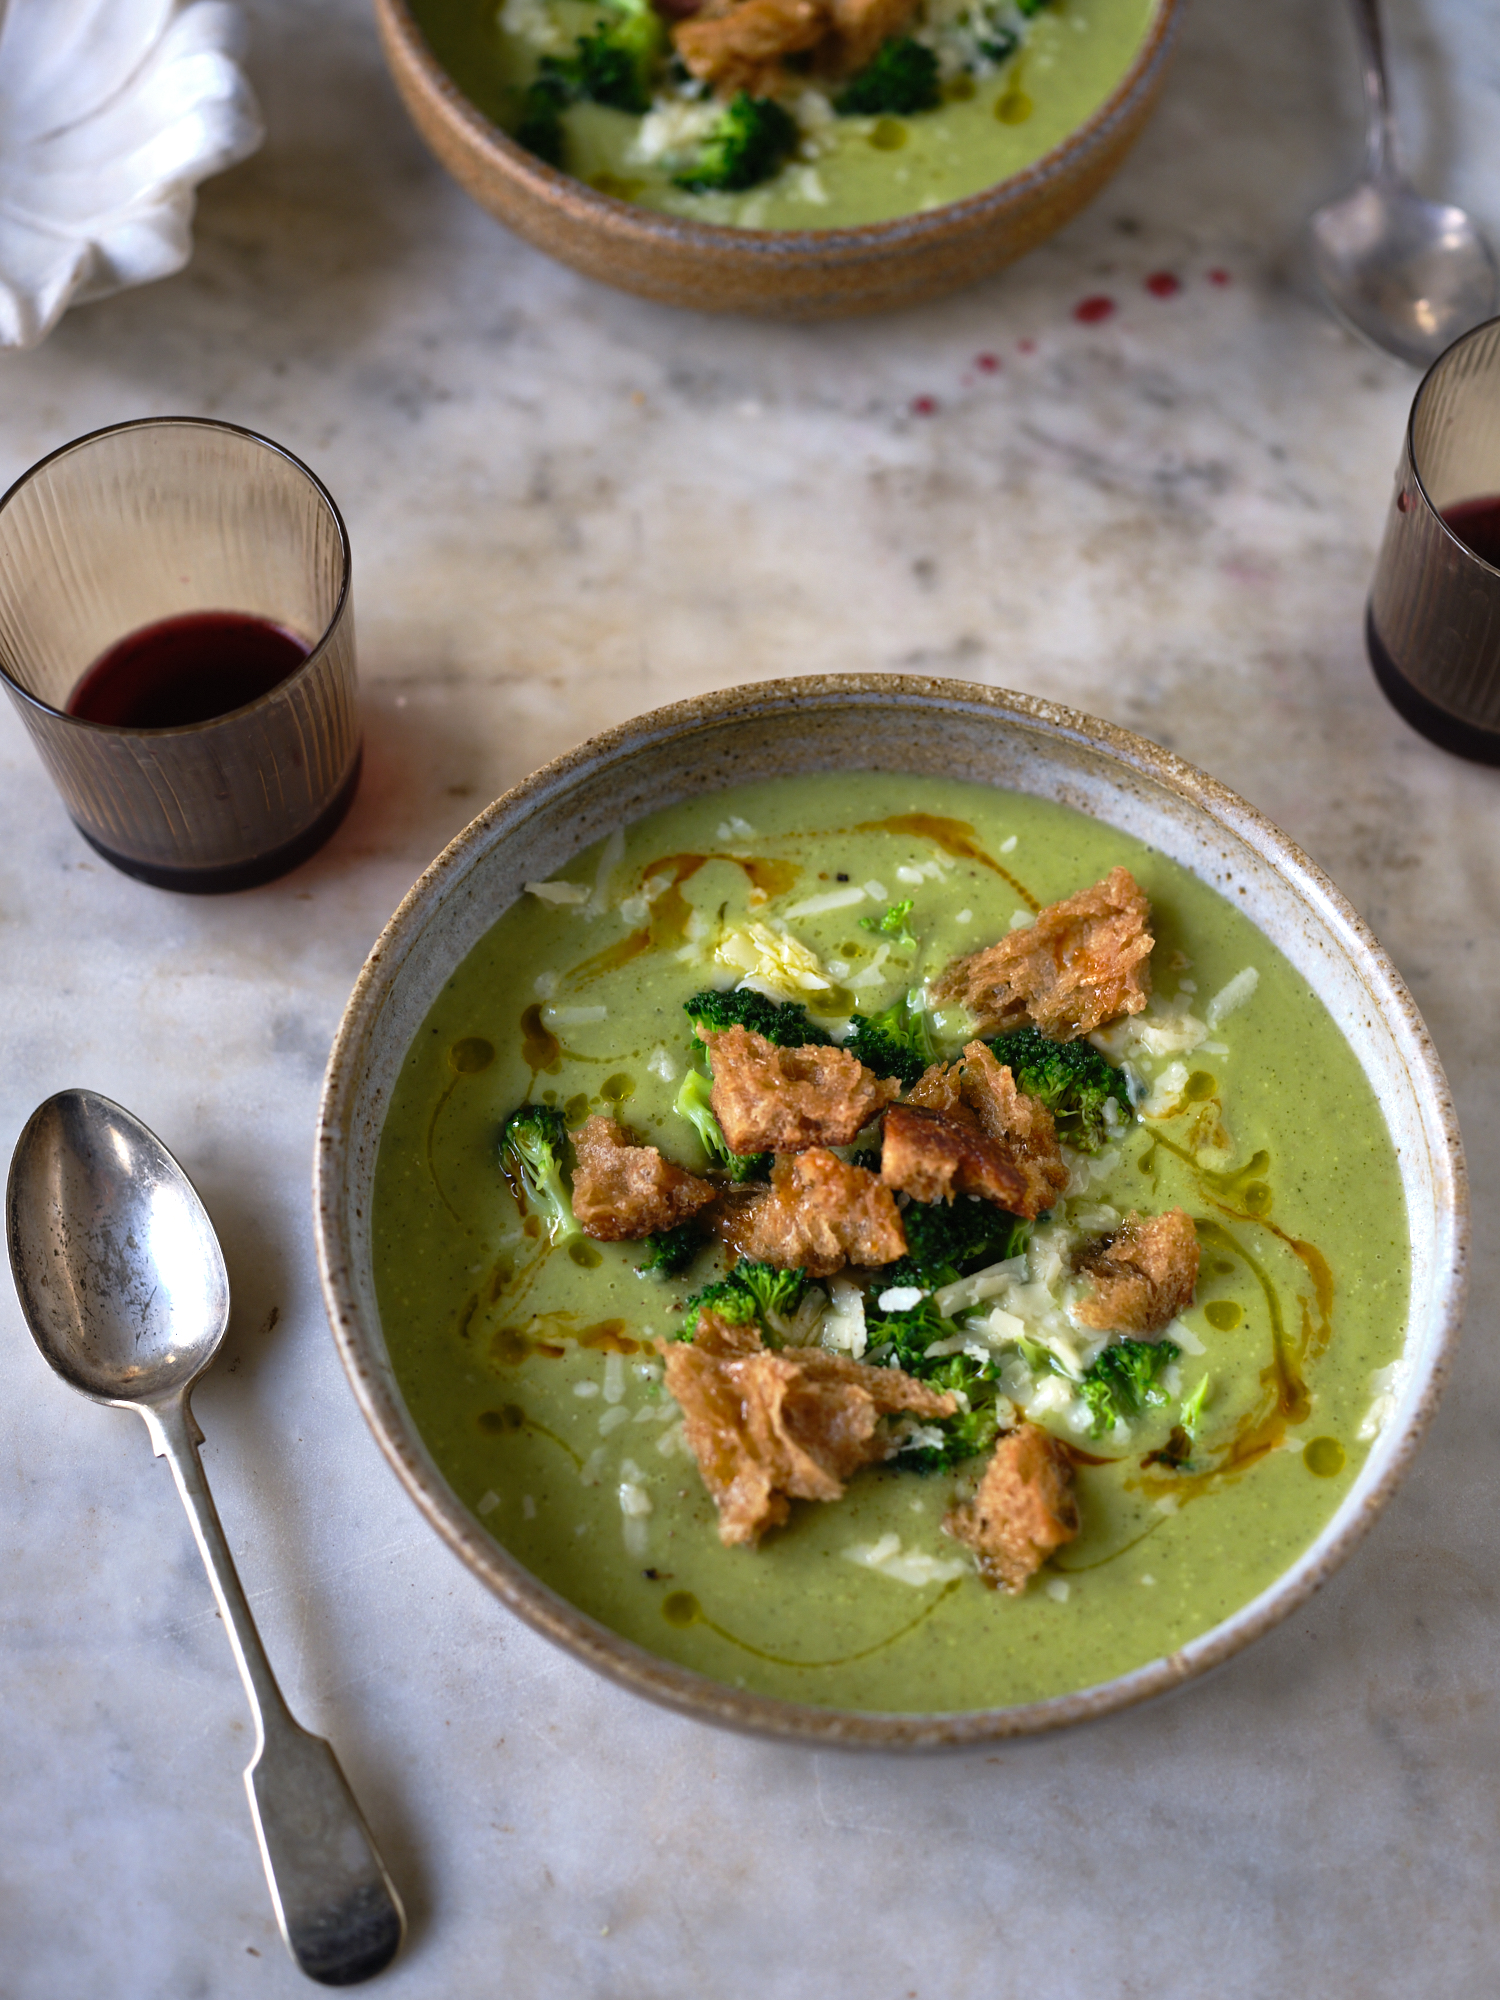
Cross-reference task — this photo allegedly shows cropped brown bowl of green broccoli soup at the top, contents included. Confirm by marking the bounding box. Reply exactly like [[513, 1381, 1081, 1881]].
[[376, 0, 1178, 318]]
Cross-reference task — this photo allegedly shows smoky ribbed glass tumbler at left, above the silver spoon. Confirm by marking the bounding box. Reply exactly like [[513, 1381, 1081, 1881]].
[[0, 416, 360, 894]]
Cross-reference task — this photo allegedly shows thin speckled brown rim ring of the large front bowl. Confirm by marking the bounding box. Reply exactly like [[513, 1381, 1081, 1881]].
[[312, 674, 1468, 1750]]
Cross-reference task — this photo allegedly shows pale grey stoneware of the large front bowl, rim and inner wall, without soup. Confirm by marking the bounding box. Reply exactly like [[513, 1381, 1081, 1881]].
[[314, 674, 1468, 1748]]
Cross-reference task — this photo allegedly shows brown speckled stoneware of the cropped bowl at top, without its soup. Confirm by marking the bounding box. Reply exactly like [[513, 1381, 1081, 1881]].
[[376, 0, 1180, 320]]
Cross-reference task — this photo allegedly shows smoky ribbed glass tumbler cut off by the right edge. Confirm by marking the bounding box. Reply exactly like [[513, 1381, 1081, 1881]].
[[1364, 320, 1500, 764]]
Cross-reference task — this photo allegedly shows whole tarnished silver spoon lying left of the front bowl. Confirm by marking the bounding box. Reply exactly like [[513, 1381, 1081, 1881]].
[[6, 1090, 406, 1986]]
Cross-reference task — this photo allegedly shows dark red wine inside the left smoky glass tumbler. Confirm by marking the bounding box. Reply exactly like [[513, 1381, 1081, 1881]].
[[68, 612, 308, 730]]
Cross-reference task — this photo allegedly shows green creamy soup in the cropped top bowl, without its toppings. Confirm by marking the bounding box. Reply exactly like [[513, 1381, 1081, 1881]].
[[412, 0, 1156, 230]]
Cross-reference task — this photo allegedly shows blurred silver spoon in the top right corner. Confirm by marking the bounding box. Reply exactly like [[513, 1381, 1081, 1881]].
[[1308, 0, 1496, 368]]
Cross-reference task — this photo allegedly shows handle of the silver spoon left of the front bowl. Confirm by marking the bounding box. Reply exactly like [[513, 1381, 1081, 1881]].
[[136, 1394, 406, 1986]]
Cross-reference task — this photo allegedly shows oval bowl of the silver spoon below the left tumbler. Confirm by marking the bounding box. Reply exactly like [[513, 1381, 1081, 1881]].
[[8, 1090, 230, 1404]]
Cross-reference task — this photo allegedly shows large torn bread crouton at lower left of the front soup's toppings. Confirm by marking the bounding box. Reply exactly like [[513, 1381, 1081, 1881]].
[[658, 1310, 958, 1548]]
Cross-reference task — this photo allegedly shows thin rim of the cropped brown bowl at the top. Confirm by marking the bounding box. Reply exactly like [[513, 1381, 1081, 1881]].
[[376, 0, 1184, 262]]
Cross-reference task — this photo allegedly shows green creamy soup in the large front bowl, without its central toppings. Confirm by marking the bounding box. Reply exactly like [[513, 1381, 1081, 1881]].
[[374, 772, 1408, 1712]]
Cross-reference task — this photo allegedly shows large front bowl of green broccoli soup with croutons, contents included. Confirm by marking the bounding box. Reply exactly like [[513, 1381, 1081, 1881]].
[[316, 676, 1466, 1746]]
